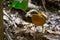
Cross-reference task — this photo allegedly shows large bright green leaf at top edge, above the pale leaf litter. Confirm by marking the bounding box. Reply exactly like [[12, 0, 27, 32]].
[[10, 0, 28, 11]]
